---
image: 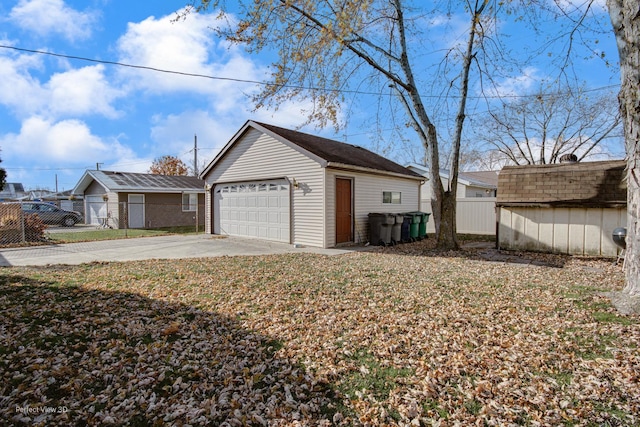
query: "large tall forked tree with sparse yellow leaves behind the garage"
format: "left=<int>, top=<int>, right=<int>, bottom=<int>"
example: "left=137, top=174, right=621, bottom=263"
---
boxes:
left=182, top=0, right=494, bottom=249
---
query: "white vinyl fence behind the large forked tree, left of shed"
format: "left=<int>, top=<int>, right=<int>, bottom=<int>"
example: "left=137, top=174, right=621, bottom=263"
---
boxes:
left=420, top=197, right=496, bottom=236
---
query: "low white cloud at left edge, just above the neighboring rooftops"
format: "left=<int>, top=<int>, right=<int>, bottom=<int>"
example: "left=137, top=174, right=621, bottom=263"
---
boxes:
left=0, top=117, right=135, bottom=166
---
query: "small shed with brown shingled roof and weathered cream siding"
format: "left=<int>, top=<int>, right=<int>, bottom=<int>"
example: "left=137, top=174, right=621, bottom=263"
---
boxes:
left=497, top=160, right=627, bottom=256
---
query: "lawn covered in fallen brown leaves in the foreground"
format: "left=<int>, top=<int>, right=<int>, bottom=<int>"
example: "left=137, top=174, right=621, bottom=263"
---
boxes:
left=0, top=241, right=640, bottom=426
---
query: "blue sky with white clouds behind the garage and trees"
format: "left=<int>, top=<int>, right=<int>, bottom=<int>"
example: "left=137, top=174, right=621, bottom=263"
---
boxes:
left=0, top=0, right=619, bottom=191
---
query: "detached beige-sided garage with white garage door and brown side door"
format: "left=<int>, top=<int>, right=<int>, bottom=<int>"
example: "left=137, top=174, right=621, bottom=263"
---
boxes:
left=200, top=121, right=424, bottom=248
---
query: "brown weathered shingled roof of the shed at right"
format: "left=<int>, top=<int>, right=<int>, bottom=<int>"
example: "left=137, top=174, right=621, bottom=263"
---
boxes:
left=496, top=160, right=627, bottom=207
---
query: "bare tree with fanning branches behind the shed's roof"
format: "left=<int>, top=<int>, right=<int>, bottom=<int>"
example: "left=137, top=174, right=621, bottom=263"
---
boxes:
left=475, top=89, right=622, bottom=165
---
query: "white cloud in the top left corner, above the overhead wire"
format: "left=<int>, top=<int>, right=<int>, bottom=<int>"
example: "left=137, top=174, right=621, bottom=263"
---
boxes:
left=9, top=0, right=96, bottom=41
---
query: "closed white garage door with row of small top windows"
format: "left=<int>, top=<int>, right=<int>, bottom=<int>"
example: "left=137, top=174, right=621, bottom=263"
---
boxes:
left=213, top=179, right=290, bottom=243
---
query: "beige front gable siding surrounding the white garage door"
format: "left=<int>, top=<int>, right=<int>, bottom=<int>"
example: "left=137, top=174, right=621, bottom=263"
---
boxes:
left=205, top=129, right=324, bottom=247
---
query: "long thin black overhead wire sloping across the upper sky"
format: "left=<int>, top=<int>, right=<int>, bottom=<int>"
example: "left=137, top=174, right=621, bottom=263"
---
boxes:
left=0, top=44, right=620, bottom=99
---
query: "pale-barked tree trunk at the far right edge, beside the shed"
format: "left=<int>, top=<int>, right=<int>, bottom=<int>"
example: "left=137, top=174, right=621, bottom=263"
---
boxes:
left=607, top=0, right=640, bottom=313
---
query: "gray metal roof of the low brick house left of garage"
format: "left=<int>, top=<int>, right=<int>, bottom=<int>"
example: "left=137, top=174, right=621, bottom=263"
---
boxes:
left=73, top=170, right=204, bottom=194
